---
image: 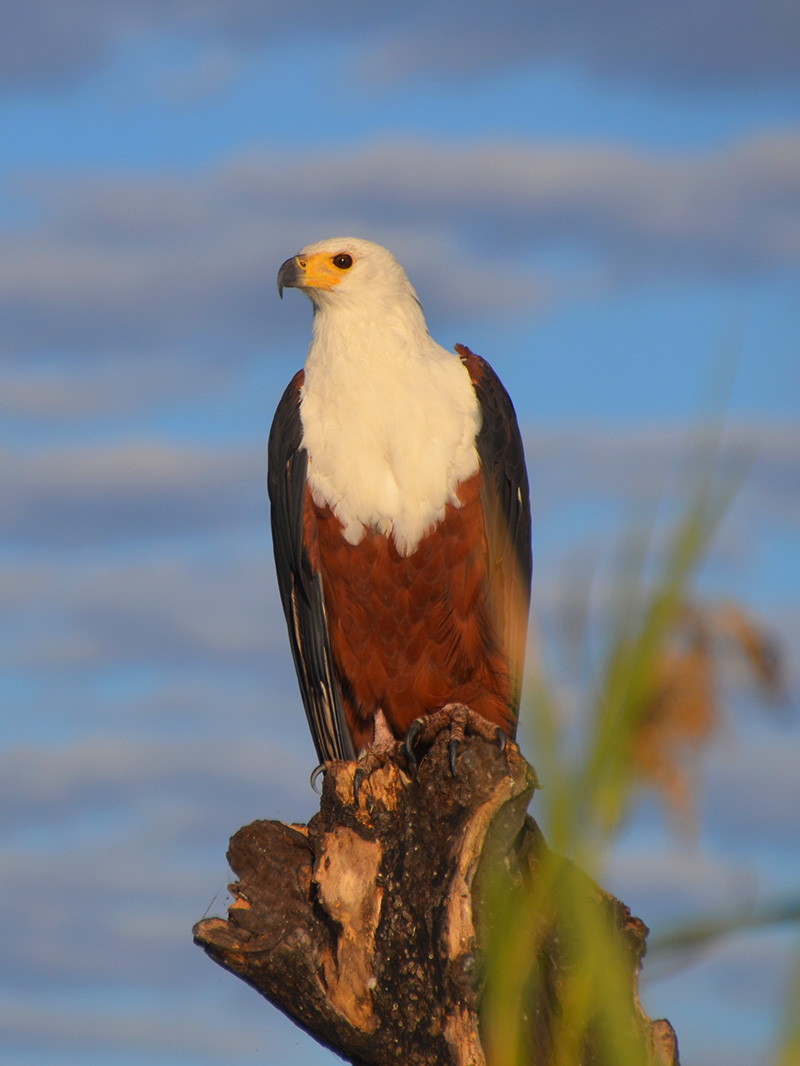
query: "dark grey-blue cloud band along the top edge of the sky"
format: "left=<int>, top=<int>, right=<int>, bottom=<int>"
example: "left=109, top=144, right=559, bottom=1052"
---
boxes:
left=0, top=0, right=800, bottom=90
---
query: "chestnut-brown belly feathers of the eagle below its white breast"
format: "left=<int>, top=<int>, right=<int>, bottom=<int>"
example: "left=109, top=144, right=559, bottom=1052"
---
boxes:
left=303, top=471, right=516, bottom=750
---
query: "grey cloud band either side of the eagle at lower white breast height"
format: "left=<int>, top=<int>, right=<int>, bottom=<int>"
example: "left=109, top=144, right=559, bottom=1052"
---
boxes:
left=0, top=420, right=800, bottom=548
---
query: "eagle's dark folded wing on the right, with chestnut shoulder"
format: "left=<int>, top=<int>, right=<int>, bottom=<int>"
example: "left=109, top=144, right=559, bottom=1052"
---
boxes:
left=455, top=344, right=533, bottom=713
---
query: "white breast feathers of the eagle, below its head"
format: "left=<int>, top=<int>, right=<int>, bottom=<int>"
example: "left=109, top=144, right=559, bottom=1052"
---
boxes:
left=300, top=314, right=481, bottom=555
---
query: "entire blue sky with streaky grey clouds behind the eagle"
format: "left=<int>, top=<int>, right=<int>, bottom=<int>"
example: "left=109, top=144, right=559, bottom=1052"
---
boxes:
left=0, top=8, right=800, bottom=1066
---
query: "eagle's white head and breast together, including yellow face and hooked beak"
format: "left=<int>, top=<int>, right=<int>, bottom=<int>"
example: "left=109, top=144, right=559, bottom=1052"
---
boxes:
left=278, top=238, right=481, bottom=555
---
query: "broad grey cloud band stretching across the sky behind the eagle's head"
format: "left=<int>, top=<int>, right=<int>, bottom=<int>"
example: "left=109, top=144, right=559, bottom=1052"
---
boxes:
left=6, top=130, right=800, bottom=360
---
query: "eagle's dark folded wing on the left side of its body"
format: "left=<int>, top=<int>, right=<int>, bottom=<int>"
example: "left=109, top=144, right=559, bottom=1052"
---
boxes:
left=267, top=370, right=355, bottom=762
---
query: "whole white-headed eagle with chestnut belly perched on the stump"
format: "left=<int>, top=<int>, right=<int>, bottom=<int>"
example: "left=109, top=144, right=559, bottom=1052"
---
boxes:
left=269, top=238, right=531, bottom=765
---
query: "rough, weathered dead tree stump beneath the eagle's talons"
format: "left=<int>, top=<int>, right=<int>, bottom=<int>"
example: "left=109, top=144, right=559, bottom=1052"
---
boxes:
left=194, top=737, right=677, bottom=1066
